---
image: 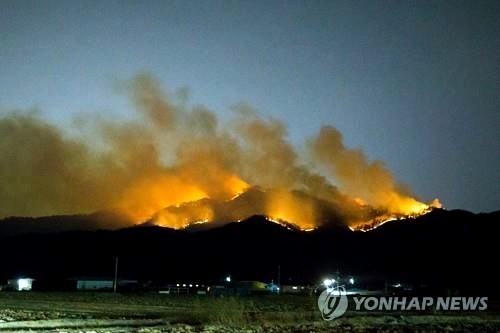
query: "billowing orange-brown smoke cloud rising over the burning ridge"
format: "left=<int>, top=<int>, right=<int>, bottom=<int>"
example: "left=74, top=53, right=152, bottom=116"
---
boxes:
left=0, top=74, right=438, bottom=228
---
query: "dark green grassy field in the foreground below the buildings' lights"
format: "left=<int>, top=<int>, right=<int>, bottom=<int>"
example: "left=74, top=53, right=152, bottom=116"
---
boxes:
left=0, top=292, right=500, bottom=333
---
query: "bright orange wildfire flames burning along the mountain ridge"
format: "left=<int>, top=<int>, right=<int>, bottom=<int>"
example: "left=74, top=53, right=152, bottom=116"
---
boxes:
left=144, top=184, right=441, bottom=231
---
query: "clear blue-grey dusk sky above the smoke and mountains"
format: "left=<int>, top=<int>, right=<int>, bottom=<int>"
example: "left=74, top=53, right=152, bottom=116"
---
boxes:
left=0, top=0, right=500, bottom=212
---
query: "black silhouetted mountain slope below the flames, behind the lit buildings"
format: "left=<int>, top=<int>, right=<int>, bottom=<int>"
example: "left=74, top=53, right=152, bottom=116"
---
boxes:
left=0, top=209, right=500, bottom=292
